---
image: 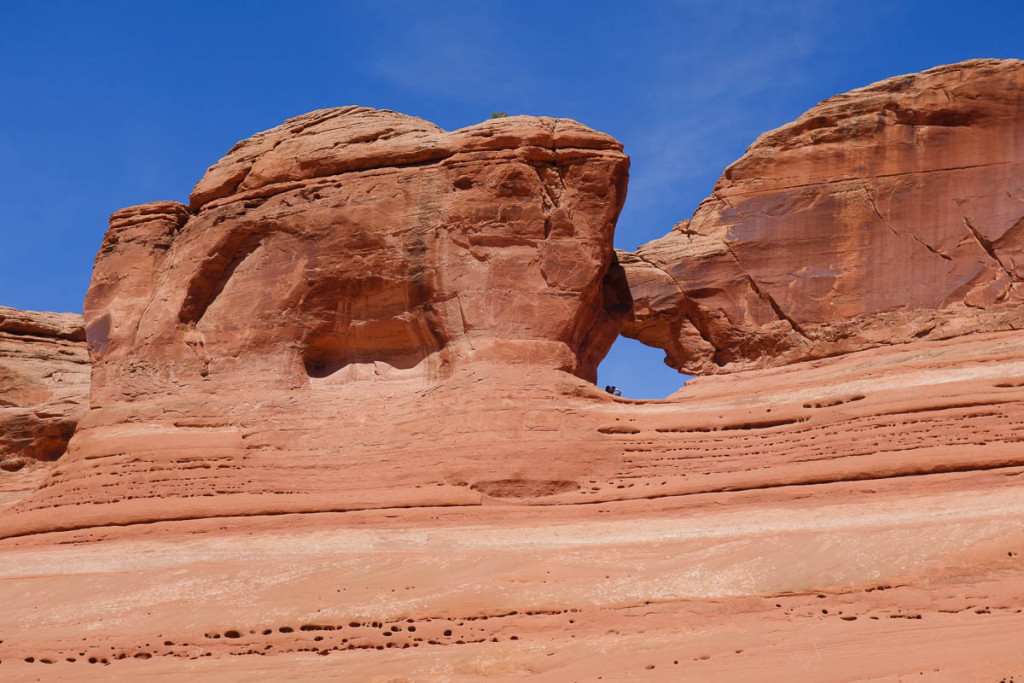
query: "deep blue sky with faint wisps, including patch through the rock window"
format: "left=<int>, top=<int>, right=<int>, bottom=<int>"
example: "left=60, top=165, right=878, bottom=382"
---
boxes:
left=0, top=0, right=1024, bottom=397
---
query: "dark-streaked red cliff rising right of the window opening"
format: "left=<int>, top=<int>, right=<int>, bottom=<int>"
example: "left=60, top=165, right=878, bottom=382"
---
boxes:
left=620, top=59, right=1024, bottom=374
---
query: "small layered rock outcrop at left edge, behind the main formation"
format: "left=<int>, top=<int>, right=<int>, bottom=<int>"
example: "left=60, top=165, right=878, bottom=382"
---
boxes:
left=0, top=306, right=89, bottom=508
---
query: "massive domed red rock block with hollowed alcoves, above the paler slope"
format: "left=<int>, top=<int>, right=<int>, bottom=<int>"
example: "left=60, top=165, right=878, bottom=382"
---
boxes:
left=92, top=108, right=628, bottom=387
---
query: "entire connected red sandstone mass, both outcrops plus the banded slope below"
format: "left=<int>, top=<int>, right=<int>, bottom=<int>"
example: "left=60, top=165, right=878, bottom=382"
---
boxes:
left=0, top=60, right=1024, bottom=683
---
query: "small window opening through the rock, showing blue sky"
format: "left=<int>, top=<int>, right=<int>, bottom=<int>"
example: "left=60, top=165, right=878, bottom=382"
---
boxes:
left=597, top=337, right=692, bottom=398
